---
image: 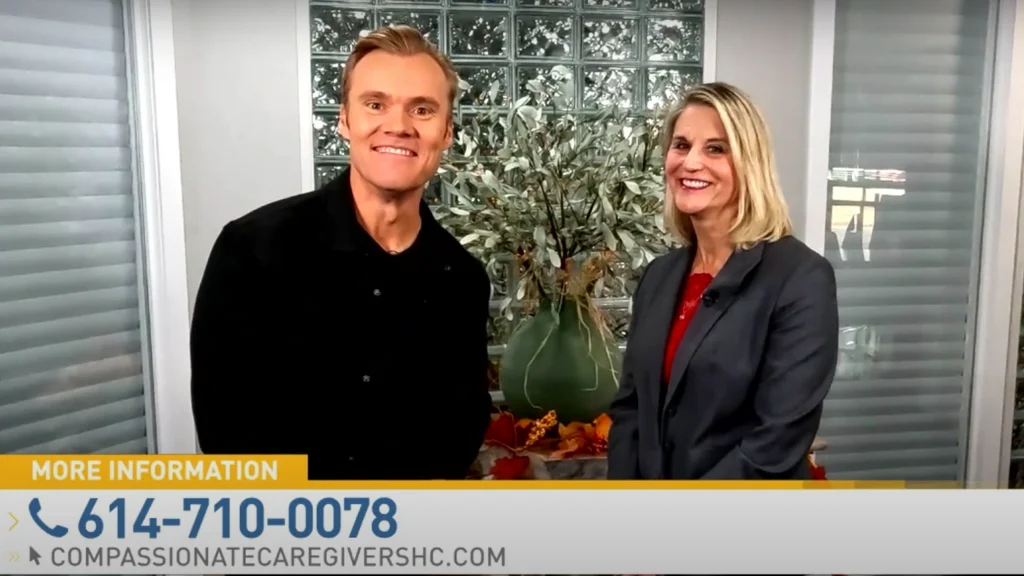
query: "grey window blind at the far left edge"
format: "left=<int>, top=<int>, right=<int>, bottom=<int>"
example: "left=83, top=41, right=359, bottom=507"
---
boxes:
left=0, top=0, right=147, bottom=453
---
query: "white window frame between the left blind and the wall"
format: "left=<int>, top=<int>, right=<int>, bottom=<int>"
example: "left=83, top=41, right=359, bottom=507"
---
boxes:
left=124, top=0, right=197, bottom=454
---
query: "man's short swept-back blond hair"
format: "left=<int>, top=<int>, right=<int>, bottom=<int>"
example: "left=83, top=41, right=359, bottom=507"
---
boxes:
left=341, top=25, right=459, bottom=115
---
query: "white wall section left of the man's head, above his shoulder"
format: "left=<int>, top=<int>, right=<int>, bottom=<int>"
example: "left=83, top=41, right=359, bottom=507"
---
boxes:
left=172, top=0, right=309, bottom=310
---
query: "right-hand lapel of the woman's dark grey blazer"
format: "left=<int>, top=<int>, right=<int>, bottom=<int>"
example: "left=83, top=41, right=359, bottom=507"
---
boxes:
left=662, top=243, right=764, bottom=412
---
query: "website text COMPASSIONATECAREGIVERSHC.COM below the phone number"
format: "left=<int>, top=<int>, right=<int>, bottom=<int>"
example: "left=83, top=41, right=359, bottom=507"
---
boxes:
left=50, top=546, right=505, bottom=568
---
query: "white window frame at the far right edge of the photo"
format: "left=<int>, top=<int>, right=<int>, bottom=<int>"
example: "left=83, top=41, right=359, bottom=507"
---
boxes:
left=967, top=0, right=1024, bottom=488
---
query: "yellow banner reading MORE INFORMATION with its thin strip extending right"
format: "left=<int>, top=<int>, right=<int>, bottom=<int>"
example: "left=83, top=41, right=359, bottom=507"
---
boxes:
left=0, top=454, right=921, bottom=490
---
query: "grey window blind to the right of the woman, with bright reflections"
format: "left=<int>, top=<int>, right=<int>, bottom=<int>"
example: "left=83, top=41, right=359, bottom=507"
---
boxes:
left=820, top=0, right=993, bottom=481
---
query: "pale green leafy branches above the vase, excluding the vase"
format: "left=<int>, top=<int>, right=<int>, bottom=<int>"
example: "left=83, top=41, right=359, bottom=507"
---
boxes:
left=436, top=67, right=669, bottom=318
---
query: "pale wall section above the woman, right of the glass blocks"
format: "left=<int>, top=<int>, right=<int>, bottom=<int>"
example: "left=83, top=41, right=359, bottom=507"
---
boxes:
left=715, top=0, right=813, bottom=238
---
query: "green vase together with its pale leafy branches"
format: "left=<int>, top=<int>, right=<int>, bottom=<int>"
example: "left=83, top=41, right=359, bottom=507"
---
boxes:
left=435, top=67, right=669, bottom=424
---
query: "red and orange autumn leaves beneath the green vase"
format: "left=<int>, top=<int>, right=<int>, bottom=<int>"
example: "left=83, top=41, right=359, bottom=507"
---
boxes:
left=477, top=410, right=611, bottom=480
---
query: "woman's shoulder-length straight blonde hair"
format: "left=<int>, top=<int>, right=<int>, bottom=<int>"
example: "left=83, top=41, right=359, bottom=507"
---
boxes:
left=662, top=82, right=793, bottom=249
